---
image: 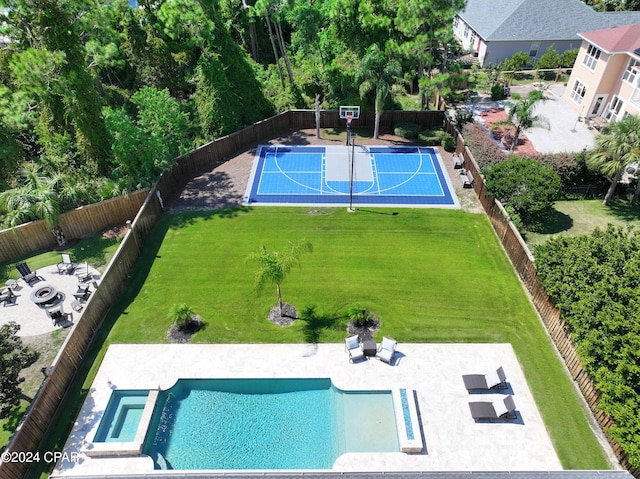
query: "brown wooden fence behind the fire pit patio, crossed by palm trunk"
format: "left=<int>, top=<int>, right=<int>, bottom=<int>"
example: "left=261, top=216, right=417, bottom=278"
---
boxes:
left=0, top=189, right=149, bottom=263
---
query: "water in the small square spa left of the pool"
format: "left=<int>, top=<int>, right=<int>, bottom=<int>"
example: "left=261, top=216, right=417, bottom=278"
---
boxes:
left=93, top=390, right=149, bottom=442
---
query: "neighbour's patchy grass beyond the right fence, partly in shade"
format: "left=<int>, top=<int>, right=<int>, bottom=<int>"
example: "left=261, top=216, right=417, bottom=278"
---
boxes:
left=527, top=200, right=640, bottom=245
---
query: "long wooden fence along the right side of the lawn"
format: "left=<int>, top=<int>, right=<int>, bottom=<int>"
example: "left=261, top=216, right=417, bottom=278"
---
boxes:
left=445, top=119, right=640, bottom=478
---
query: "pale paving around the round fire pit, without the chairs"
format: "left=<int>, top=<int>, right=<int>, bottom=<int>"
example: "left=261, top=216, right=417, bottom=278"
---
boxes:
left=0, top=264, right=99, bottom=337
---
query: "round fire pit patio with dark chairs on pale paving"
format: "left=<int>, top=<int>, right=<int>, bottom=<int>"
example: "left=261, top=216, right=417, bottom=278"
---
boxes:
left=0, top=253, right=99, bottom=336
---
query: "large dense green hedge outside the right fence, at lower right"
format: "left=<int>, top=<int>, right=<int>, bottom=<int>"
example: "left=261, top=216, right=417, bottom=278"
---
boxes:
left=534, top=225, right=640, bottom=467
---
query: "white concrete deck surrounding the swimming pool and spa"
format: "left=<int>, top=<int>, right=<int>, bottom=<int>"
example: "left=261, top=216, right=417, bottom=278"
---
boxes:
left=52, top=343, right=562, bottom=477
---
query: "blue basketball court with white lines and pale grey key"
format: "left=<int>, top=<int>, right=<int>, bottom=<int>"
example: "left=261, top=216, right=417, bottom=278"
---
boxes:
left=244, top=145, right=460, bottom=208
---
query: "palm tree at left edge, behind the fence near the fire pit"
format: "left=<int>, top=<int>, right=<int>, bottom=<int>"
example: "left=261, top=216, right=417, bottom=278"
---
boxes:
left=0, top=166, right=74, bottom=246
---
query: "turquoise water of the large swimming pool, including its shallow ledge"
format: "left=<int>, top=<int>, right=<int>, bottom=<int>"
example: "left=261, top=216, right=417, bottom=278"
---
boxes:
left=143, top=379, right=399, bottom=470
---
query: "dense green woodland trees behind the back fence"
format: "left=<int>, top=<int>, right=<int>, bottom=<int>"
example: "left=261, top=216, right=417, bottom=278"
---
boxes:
left=0, top=0, right=464, bottom=228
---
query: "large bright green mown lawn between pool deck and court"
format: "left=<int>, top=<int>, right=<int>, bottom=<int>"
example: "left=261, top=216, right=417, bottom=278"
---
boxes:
left=28, top=208, right=608, bottom=476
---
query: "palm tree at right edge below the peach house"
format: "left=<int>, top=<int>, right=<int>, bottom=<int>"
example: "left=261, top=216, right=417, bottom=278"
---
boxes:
left=587, top=115, right=640, bottom=205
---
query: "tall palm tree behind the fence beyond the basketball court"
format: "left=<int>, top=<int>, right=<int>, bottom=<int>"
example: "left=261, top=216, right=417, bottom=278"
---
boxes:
left=356, top=43, right=402, bottom=139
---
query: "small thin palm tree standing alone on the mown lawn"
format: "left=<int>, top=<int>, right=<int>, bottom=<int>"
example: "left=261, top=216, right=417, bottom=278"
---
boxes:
left=247, top=238, right=312, bottom=312
